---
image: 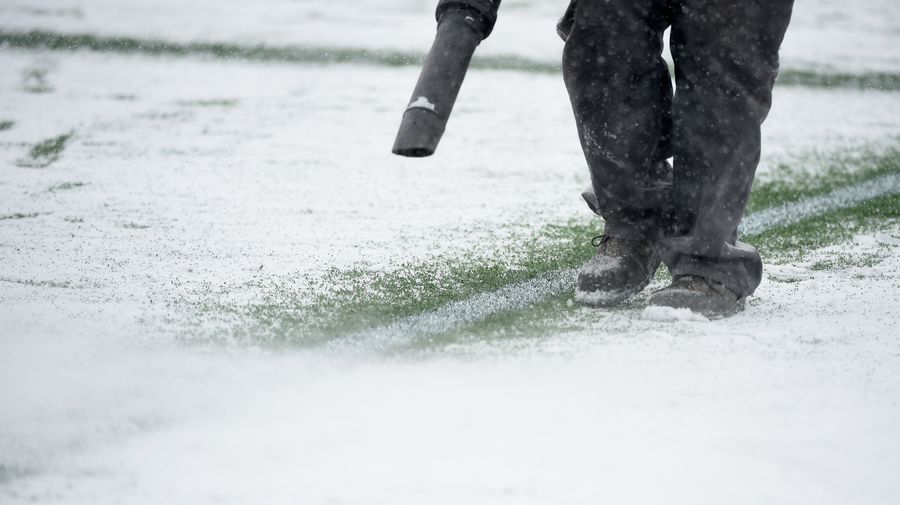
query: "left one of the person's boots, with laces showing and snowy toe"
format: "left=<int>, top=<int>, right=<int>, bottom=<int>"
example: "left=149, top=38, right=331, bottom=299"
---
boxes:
left=575, top=235, right=662, bottom=307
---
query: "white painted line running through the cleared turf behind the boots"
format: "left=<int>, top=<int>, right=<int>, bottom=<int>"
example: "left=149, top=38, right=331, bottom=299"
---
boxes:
left=330, top=170, right=900, bottom=351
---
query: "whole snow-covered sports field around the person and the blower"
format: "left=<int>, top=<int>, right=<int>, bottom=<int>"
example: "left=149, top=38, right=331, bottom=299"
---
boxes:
left=0, top=0, right=900, bottom=504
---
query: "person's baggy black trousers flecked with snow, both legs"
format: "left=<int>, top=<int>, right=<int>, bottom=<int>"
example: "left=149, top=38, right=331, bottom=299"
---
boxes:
left=559, top=0, right=793, bottom=295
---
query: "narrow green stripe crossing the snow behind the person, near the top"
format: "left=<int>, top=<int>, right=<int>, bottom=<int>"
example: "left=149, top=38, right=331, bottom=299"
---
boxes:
left=0, top=30, right=900, bottom=91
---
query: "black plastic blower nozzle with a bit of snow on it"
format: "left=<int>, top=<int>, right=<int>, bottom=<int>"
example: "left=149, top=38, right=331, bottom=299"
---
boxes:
left=393, top=0, right=500, bottom=157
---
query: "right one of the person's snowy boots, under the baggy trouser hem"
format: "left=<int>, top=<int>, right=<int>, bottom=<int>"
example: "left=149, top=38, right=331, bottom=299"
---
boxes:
left=649, top=275, right=745, bottom=318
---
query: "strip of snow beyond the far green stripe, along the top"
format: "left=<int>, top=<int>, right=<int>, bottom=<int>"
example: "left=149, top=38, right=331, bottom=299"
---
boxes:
left=0, top=0, right=900, bottom=73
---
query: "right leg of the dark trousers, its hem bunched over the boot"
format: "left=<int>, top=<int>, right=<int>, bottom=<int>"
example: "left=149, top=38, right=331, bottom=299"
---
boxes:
left=662, top=0, right=793, bottom=296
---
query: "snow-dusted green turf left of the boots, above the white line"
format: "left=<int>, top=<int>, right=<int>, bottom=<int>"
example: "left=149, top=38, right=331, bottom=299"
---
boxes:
left=203, top=221, right=600, bottom=345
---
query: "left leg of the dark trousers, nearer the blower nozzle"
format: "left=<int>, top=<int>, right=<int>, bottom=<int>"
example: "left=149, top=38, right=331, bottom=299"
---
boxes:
left=563, top=0, right=672, bottom=239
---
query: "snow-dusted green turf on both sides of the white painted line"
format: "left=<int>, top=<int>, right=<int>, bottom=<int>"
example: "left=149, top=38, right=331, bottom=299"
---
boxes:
left=183, top=142, right=900, bottom=346
